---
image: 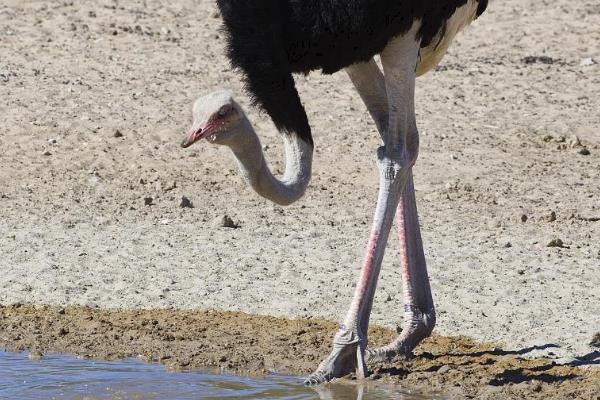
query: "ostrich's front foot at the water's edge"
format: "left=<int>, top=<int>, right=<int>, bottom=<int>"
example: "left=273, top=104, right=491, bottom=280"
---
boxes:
left=304, top=328, right=368, bottom=386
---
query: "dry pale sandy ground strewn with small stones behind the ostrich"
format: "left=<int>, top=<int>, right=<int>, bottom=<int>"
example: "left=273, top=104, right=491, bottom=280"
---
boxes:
left=0, top=0, right=600, bottom=390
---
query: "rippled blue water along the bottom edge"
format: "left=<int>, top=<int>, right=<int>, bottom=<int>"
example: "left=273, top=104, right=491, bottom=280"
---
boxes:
left=0, top=351, right=431, bottom=400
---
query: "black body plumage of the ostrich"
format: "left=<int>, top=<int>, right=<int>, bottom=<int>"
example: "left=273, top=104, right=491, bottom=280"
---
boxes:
left=217, top=0, right=487, bottom=144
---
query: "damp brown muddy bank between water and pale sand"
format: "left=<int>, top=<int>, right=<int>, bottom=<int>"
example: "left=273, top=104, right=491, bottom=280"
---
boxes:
left=0, top=305, right=600, bottom=399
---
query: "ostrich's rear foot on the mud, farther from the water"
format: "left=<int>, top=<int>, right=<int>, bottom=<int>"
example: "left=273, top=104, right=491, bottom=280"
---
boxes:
left=367, top=307, right=435, bottom=363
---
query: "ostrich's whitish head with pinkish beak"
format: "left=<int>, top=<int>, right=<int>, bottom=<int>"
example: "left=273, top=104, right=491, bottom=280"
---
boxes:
left=181, top=90, right=245, bottom=147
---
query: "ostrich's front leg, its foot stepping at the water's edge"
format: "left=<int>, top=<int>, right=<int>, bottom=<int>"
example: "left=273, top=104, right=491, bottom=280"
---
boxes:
left=305, top=30, right=419, bottom=385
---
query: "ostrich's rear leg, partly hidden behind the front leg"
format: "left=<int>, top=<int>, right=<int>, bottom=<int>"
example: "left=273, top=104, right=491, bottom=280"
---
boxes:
left=347, top=60, right=435, bottom=361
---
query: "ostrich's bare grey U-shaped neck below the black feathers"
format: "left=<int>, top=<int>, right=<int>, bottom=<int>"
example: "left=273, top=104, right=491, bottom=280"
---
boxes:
left=230, top=120, right=313, bottom=206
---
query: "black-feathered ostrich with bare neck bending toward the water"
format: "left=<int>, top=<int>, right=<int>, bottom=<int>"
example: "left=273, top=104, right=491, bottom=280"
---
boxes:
left=181, top=0, right=487, bottom=385
